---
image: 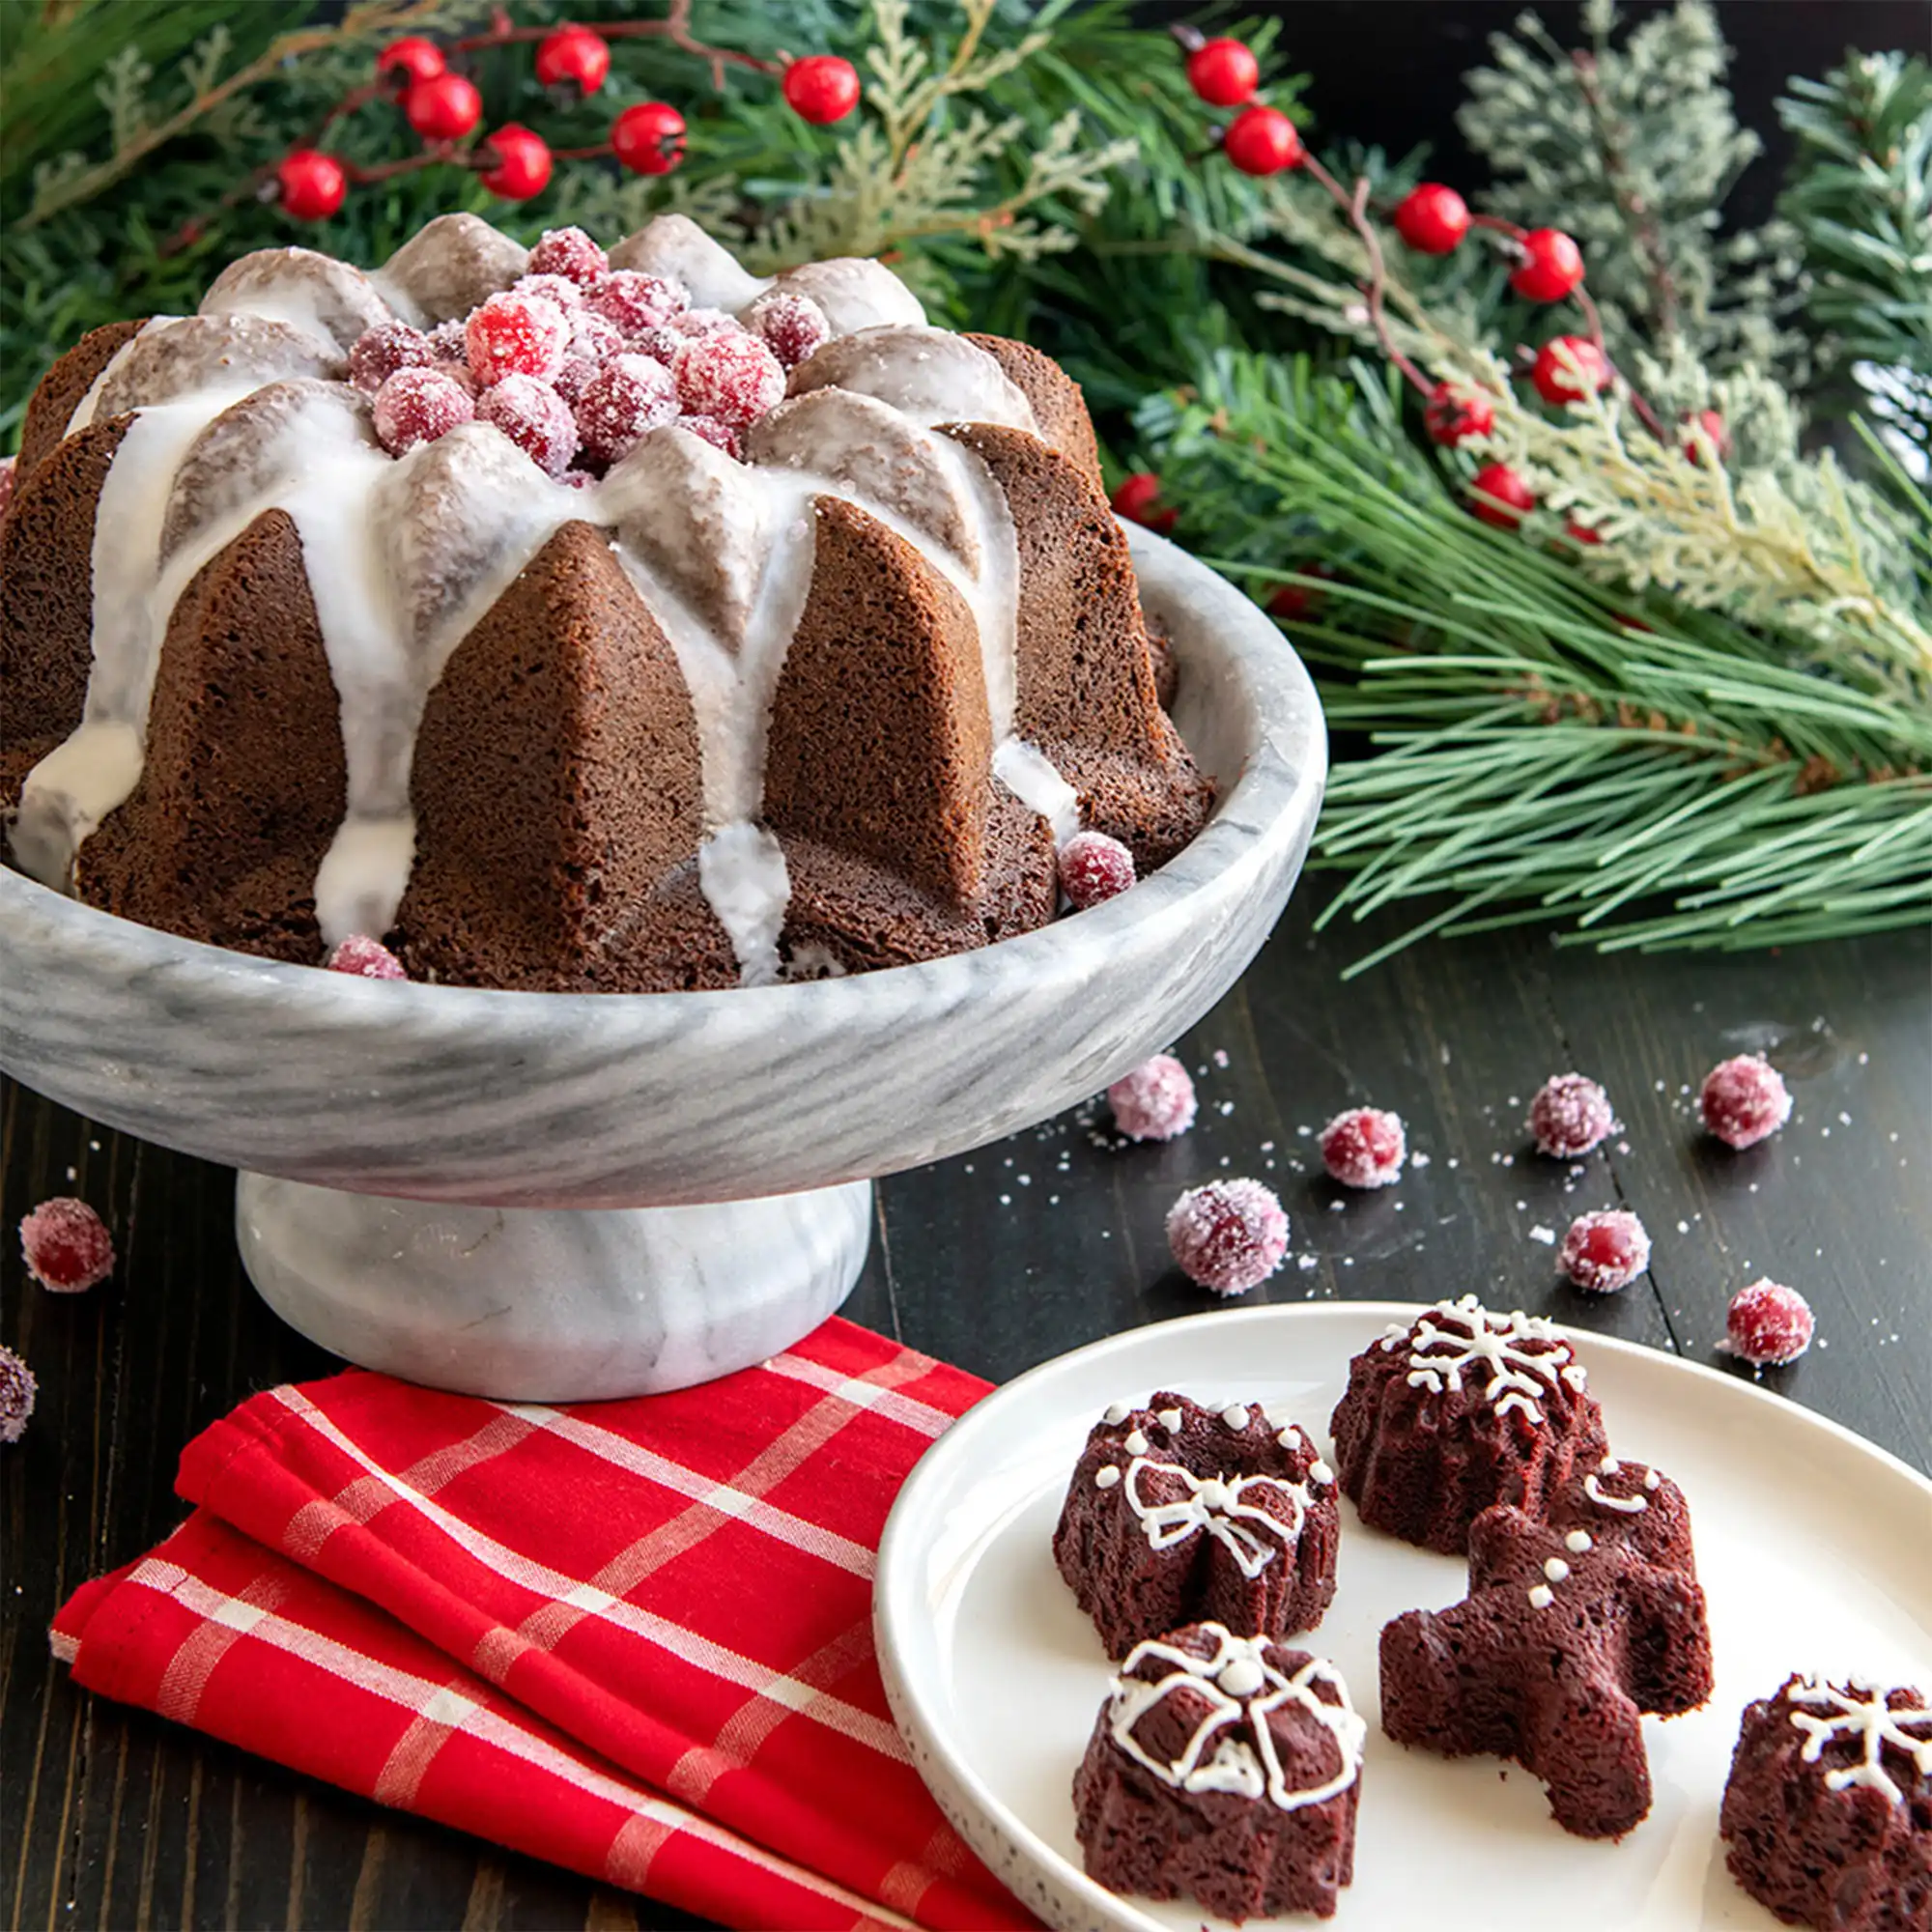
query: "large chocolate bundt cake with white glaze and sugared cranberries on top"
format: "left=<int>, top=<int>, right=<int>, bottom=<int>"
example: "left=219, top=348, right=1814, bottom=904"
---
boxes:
left=0, top=214, right=1213, bottom=993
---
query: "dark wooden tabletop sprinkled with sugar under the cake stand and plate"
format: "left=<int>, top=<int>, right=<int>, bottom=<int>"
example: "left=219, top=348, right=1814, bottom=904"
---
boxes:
left=0, top=912, right=1932, bottom=1928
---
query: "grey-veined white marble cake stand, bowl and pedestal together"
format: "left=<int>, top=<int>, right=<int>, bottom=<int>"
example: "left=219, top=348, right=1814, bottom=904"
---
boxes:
left=0, top=529, right=1327, bottom=1401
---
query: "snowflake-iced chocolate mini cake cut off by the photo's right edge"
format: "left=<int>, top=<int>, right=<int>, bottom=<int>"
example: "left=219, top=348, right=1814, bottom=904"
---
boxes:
left=1719, top=1675, right=1932, bottom=1932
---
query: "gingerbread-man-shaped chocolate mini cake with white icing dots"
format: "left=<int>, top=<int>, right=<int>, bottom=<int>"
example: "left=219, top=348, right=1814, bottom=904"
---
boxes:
left=1381, top=1457, right=1712, bottom=1837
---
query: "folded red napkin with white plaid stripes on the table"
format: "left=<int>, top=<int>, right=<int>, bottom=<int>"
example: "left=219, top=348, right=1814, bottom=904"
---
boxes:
left=54, top=1320, right=1034, bottom=1928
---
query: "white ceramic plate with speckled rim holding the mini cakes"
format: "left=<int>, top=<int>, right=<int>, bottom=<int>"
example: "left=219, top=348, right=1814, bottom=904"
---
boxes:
left=875, top=1302, right=1932, bottom=1932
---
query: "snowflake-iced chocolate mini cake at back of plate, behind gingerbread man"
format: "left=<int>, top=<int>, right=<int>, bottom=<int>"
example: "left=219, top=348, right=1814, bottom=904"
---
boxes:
left=1329, top=1294, right=1605, bottom=1553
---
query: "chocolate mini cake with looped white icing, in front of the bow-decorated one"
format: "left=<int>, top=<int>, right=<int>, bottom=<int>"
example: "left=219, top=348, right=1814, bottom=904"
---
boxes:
left=1074, top=1623, right=1368, bottom=1920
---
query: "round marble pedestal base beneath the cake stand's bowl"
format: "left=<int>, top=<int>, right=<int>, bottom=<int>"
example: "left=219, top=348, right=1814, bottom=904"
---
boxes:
left=236, top=1173, right=871, bottom=1403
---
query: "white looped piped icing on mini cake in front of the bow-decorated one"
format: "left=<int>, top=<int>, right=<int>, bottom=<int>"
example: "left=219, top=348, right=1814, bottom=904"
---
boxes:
left=1111, top=1623, right=1368, bottom=1810
